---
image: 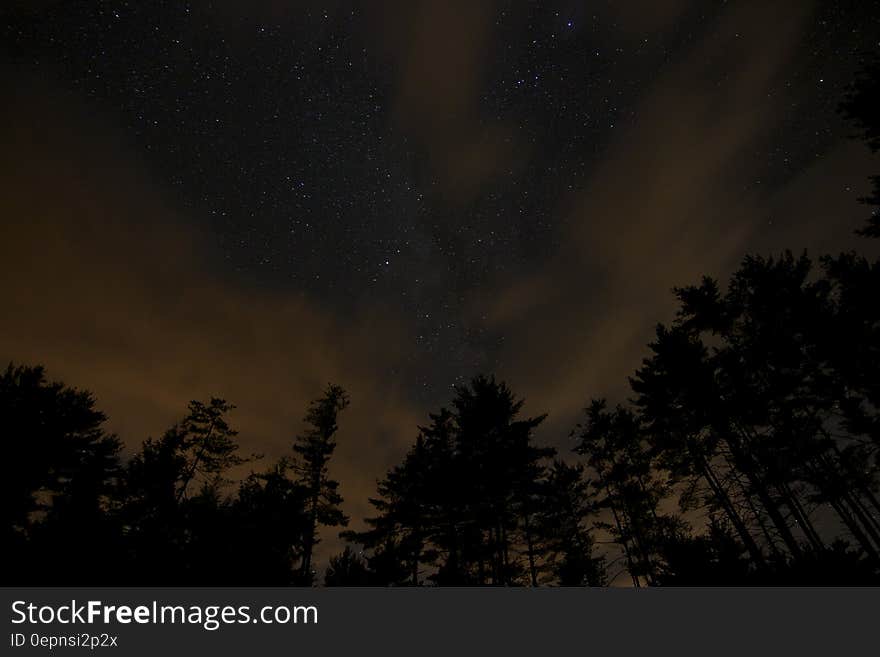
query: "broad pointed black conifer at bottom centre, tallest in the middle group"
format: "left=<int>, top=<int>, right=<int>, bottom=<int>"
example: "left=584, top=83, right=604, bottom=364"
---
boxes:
left=344, top=376, right=568, bottom=586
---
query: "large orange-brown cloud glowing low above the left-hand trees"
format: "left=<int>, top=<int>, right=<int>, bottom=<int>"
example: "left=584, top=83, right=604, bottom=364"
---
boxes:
left=0, top=75, right=422, bottom=560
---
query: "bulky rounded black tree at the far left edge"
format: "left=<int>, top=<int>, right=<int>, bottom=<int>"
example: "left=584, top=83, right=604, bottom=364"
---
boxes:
left=0, top=363, right=121, bottom=584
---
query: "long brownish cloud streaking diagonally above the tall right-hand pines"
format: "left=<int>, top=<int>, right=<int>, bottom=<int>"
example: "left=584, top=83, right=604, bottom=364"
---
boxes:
left=472, top=3, right=852, bottom=436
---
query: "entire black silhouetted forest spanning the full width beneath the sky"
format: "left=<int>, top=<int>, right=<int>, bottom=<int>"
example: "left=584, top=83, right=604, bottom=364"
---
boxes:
left=0, top=60, right=880, bottom=587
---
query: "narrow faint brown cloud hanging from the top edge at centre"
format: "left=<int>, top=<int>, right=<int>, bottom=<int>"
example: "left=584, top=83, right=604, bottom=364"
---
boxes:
left=367, top=0, right=525, bottom=203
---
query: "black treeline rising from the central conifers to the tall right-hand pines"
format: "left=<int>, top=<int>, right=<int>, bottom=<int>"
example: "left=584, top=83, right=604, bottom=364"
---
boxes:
left=331, top=253, right=880, bottom=586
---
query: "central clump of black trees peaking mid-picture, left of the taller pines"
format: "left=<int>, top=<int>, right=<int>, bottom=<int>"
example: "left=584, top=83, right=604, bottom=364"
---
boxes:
left=329, top=376, right=605, bottom=586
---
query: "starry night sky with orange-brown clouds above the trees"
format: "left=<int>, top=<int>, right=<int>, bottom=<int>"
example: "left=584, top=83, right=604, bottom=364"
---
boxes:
left=0, top=0, right=880, bottom=552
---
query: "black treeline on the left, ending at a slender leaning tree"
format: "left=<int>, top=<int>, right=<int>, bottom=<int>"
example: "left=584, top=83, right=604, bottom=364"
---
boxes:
left=0, top=364, right=348, bottom=586
